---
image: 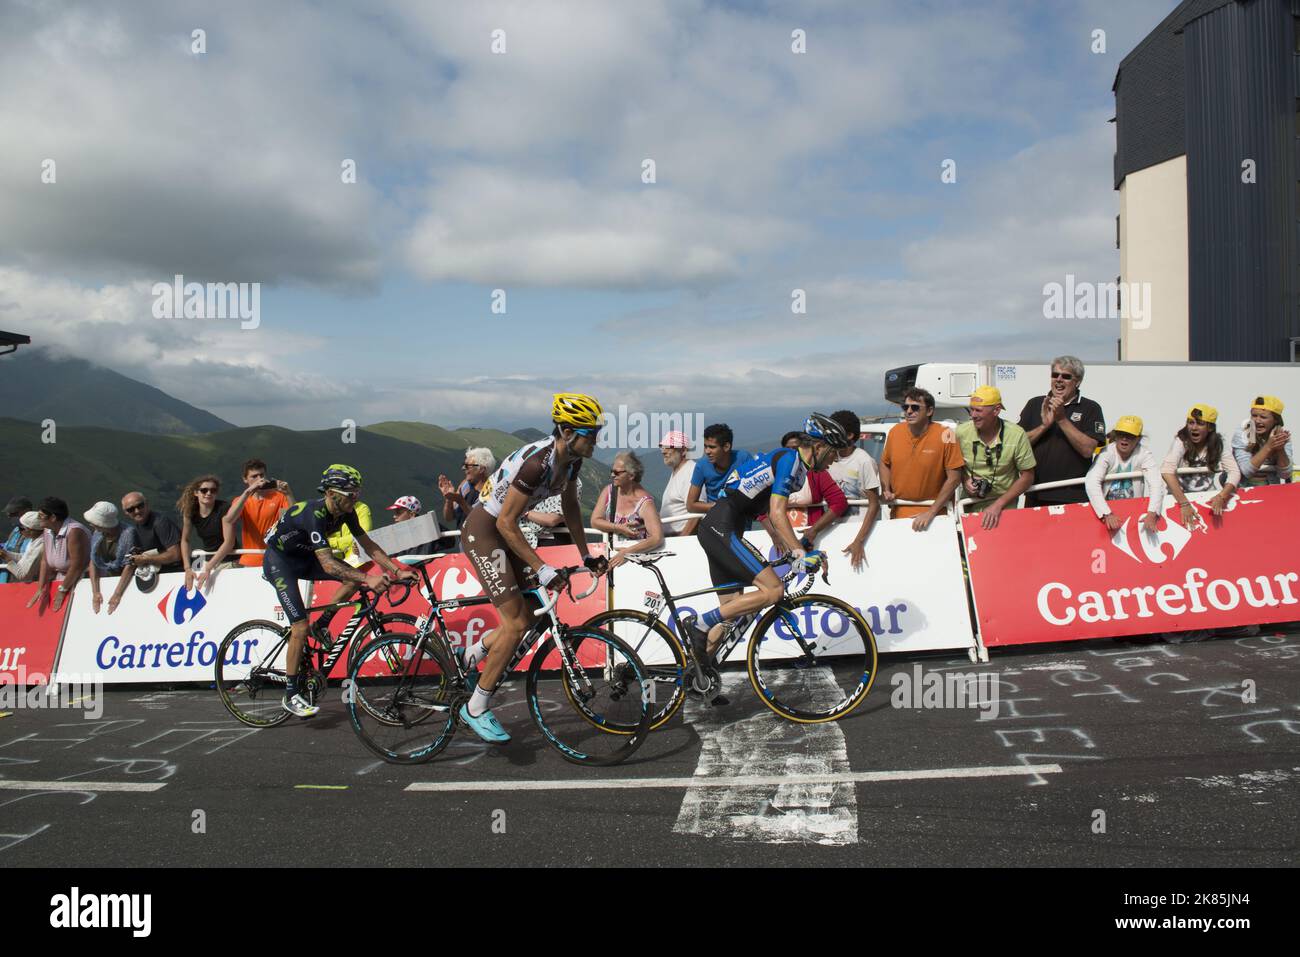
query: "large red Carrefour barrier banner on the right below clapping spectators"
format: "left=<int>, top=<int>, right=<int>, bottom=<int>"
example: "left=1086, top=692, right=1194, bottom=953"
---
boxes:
left=962, top=485, right=1300, bottom=645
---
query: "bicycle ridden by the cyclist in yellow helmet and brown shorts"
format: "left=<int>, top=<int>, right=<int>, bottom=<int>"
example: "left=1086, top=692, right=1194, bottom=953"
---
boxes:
left=345, top=559, right=651, bottom=766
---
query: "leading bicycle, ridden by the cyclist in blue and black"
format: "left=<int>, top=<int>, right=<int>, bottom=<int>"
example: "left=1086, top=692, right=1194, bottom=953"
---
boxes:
left=586, top=551, right=876, bottom=728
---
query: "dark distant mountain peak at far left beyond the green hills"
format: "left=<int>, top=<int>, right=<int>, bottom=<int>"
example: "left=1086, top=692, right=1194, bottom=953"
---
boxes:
left=0, top=348, right=235, bottom=436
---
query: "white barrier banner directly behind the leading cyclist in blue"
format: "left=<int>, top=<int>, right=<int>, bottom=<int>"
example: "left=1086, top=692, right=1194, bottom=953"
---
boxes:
left=610, top=515, right=975, bottom=664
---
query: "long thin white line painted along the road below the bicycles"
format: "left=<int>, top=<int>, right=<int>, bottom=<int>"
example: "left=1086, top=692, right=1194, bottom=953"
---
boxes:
left=406, top=764, right=1062, bottom=792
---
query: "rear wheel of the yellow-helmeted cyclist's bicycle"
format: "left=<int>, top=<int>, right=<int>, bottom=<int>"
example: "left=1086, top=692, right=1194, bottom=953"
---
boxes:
left=343, top=633, right=464, bottom=765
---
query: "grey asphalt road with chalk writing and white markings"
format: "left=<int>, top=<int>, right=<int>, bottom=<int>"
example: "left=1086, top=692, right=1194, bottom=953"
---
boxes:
left=0, top=633, right=1300, bottom=867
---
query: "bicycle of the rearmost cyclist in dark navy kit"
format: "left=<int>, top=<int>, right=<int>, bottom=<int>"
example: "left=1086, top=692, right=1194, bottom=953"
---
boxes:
left=216, top=581, right=416, bottom=728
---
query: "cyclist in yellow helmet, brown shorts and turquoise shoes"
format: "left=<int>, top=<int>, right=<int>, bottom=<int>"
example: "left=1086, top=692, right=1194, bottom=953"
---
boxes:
left=460, top=393, right=606, bottom=742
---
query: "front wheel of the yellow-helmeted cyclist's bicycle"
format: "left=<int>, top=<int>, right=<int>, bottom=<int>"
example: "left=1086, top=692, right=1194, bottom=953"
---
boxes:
left=528, top=625, right=654, bottom=766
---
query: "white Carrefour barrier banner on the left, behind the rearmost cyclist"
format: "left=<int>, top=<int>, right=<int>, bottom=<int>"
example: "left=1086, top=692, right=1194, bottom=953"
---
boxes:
left=56, top=567, right=299, bottom=683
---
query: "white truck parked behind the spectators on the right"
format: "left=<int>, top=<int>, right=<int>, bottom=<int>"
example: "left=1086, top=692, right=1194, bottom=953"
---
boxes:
left=863, top=359, right=1300, bottom=458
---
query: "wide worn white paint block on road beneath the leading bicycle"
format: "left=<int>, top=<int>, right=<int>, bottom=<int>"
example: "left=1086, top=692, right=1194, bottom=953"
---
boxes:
left=672, top=668, right=858, bottom=844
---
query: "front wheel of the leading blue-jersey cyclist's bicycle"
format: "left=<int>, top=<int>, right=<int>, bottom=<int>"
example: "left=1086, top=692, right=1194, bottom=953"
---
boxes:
left=746, top=594, right=876, bottom=724
